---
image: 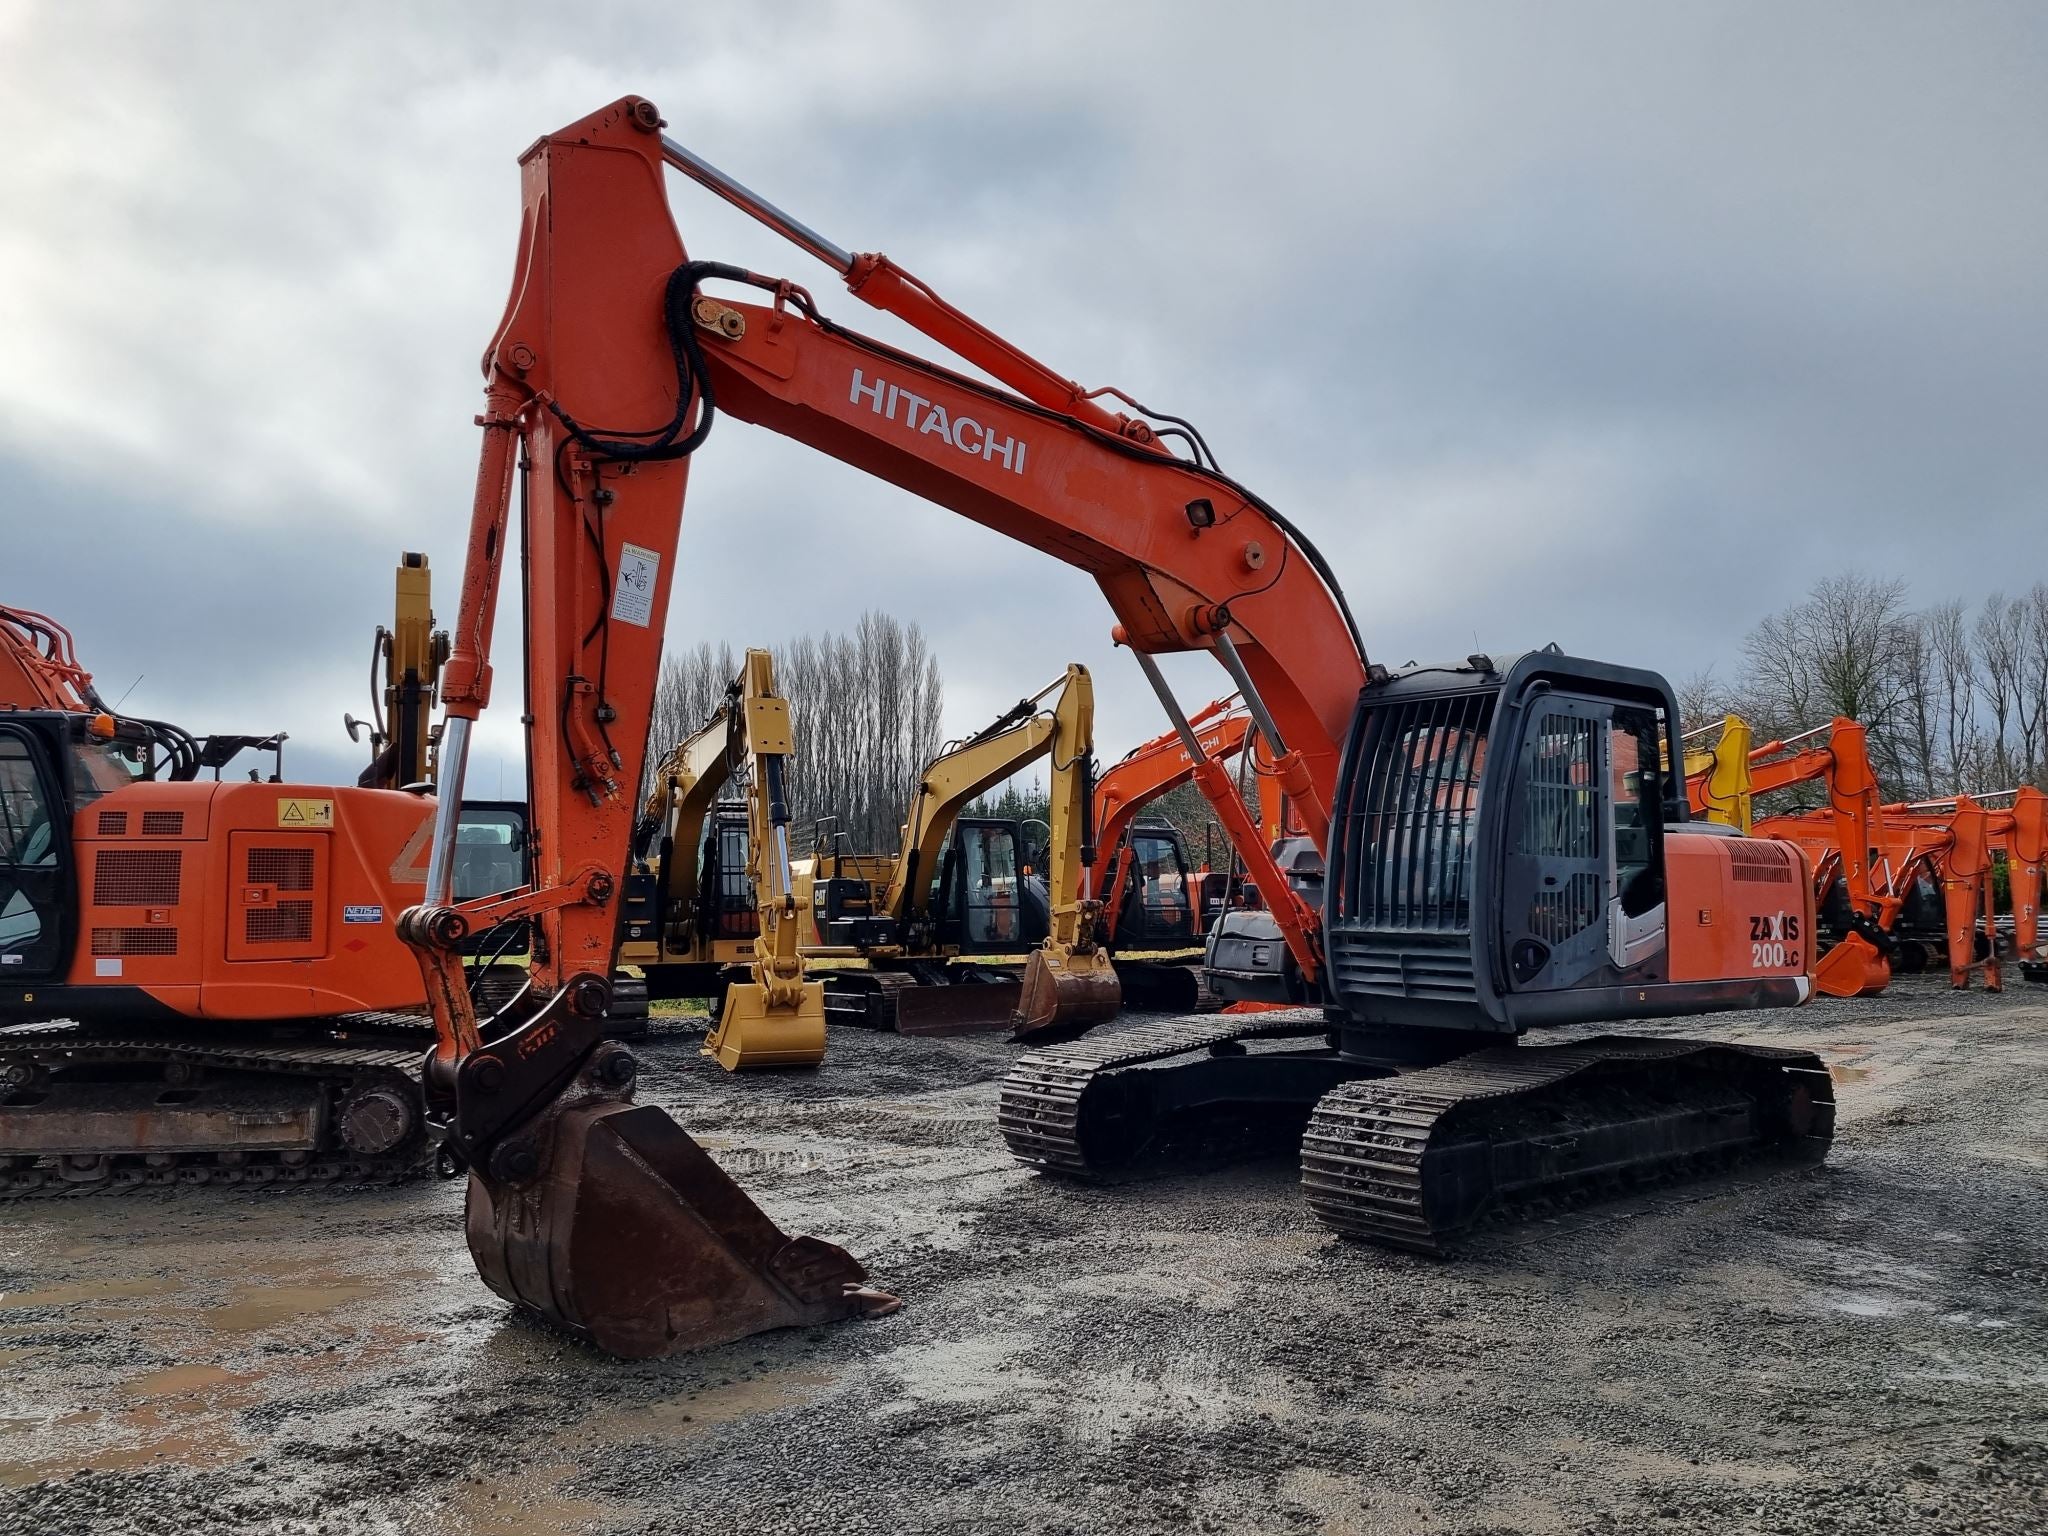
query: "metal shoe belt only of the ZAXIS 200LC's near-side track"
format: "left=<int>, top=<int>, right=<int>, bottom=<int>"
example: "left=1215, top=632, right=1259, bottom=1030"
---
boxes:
left=1300, top=1038, right=1835, bottom=1253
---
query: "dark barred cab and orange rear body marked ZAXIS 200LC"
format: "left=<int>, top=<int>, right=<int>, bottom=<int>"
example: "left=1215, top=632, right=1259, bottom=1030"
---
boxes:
left=1325, top=651, right=1812, bottom=1051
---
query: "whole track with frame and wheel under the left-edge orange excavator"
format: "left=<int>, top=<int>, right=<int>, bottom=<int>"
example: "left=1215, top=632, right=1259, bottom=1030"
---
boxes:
left=0, top=1014, right=432, bottom=1200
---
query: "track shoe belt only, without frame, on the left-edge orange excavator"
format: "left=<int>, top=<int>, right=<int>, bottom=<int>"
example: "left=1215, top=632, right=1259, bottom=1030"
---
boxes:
left=0, top=1012, right=432, bottom=1200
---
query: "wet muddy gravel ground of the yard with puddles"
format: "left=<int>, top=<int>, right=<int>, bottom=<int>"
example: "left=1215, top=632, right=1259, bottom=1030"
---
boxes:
left=0, top=981, right=2048, bottom=1536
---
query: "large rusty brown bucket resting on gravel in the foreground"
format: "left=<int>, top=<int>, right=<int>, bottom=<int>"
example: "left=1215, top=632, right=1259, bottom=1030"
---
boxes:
left=467, top=1100, right=901, bottom=1360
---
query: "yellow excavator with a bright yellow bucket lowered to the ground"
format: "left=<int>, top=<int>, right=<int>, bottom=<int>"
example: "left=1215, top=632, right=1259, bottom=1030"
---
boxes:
left=618, top=649, right=825, bottom=1071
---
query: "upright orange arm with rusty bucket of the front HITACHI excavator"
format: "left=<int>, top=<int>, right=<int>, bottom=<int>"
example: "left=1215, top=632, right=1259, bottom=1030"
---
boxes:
left=399, top=100, right=895, bottom=1356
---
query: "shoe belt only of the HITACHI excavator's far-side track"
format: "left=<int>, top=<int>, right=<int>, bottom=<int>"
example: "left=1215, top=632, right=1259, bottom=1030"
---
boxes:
left=995, top=1008, right=1329, bottom=1180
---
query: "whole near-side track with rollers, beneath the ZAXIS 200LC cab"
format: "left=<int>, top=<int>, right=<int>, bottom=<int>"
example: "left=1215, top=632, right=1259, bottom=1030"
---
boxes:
left=1300, top=1034, right=1835, bottom=1253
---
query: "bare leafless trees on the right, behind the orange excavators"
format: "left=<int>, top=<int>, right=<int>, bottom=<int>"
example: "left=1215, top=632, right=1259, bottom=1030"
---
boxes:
left=1679, top=571, right=2048, bottom=799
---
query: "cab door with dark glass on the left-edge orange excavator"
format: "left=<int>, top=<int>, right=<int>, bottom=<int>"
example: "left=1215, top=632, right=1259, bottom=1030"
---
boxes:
left=0, top=725, right=72, bottom=987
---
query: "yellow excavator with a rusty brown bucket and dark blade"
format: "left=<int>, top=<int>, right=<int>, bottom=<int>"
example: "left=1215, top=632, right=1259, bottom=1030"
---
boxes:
left=797, top=666, right=1120, bottom=1038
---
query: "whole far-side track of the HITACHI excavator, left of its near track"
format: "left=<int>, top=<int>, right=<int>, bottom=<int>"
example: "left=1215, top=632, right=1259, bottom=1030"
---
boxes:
left=995, top=1008, right=1354, bottom=1180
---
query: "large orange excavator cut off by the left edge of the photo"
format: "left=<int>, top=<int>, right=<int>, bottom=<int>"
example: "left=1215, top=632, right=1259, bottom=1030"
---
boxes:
left=0, top=608, right=452, bottom=1198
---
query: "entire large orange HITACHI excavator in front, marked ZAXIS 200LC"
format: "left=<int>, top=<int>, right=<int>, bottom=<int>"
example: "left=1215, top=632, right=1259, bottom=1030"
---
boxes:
left=376, top=96, right=1833, bottom=1354
